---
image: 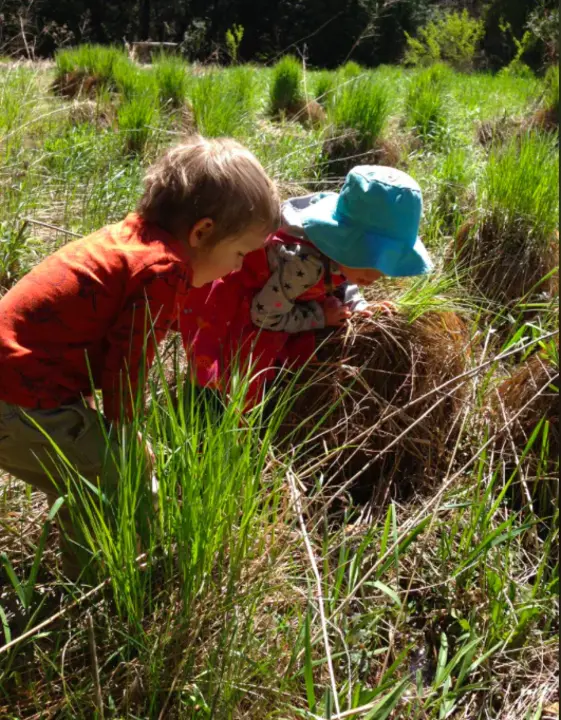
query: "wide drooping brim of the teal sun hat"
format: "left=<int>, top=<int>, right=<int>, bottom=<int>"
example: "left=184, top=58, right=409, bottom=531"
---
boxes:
left=298, top=195, right=433, bottom=277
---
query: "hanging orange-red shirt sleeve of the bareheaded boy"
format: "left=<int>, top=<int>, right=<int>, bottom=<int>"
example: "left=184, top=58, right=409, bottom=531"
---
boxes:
left=101, top=266, right=180, bottom=422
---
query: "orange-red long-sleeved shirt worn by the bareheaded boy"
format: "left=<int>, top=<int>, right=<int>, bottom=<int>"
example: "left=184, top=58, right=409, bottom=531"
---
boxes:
left=0, top=214, right=191, bottom=420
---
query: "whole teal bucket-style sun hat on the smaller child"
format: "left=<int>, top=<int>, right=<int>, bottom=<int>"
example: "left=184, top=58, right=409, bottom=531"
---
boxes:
left=298, top=165, right=433, bottom=277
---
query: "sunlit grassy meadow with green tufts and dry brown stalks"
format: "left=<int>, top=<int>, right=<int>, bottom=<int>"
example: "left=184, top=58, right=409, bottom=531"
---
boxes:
left=0, top=46, right=559, bottom=720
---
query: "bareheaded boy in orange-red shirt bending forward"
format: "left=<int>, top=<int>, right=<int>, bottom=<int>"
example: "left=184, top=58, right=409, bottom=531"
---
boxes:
left=0, top=138, right=280, bottom=567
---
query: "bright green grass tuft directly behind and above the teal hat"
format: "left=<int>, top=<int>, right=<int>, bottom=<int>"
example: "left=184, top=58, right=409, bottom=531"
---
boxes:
left=333, top=77, right=390, bottom=149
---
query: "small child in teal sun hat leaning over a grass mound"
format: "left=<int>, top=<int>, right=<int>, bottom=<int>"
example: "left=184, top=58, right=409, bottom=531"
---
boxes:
left=181, top=166, right=432, bottom=405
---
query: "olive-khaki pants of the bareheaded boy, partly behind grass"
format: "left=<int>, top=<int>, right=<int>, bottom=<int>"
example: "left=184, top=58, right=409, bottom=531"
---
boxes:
left=0, top=400, right=150, bottom=579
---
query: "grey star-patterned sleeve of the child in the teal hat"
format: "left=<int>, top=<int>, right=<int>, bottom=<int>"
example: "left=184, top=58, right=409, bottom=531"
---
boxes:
left=251, top=245, right=325, bottom=333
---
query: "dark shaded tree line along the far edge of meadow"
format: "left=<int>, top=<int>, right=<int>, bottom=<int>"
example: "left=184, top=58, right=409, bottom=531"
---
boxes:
left=0, top=0, right=556, bottom=68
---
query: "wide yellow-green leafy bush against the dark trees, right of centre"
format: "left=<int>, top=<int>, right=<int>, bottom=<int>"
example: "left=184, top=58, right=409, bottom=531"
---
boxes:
left=404, top=10, right=485, bottom=71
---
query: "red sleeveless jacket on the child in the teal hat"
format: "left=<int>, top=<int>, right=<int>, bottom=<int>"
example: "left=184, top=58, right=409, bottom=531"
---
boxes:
left=180, top=232, right=346, bottom=406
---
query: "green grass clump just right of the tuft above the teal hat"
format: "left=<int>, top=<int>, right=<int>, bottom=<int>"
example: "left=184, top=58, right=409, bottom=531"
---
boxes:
left=405, top=65, right=447, bottom=142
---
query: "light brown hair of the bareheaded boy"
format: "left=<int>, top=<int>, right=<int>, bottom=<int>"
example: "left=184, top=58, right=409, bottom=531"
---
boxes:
left=137, top=136, right=280, bottom=244
